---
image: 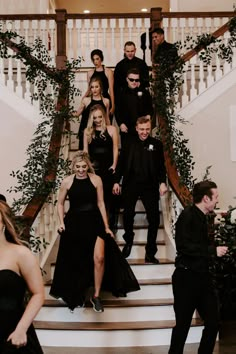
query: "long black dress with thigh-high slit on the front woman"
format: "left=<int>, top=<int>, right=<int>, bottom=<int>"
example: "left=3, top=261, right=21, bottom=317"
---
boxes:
left=50, top=177, right=139, bottom=310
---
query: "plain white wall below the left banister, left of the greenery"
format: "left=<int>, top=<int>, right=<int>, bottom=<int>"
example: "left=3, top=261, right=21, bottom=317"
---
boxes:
left=0, top=86, right=39, bottom=204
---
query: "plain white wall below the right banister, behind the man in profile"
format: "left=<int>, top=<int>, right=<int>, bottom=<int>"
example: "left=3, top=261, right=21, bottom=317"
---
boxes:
left=179, top=84, right=236, bottom=209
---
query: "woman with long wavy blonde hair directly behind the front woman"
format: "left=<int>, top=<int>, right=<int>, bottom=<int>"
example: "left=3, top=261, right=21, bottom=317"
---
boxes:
left=84, top=105, right=119, bottom=230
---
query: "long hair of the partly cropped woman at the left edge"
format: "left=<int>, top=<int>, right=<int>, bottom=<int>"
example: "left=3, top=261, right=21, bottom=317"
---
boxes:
left=0, top=200, right=21, bottom=245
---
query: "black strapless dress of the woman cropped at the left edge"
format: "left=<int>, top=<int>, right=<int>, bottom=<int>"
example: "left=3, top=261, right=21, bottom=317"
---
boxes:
left=0, top=269, right=43, bottom=354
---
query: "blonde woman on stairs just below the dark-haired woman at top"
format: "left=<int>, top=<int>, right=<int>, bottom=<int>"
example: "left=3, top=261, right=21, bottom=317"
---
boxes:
left=75, top=77, right=110, bottom=150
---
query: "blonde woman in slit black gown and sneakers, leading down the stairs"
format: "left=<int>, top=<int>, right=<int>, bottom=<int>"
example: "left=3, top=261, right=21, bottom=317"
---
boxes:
left=50, top=151, right=139, bottom=312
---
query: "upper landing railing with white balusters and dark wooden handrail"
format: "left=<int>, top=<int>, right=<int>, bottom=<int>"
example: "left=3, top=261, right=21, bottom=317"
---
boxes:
left=0, top=8, right=234, bottom=67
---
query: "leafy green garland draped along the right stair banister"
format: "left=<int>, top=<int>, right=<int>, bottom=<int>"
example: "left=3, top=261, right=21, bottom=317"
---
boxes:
left=152, top=17, right=236, bottom=194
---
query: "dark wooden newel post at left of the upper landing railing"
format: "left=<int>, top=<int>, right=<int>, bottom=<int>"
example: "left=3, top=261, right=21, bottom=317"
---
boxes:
left=56, top=9, right=67, bottom=70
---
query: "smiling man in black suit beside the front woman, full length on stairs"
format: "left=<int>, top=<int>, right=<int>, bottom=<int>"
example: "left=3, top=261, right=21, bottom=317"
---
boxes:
left=113, top=117, right=167, bottom=264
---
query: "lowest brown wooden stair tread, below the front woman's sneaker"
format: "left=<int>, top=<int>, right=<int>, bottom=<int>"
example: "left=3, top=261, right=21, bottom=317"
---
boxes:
left=34, top=319, right=203, bottom=331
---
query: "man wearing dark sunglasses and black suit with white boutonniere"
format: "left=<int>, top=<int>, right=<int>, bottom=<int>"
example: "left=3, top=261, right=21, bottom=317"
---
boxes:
left=116, top=68, right=153, bottom=146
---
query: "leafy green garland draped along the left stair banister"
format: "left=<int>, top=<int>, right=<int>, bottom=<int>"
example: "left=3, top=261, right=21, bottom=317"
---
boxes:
left=0, top=28, right=81, bottom=213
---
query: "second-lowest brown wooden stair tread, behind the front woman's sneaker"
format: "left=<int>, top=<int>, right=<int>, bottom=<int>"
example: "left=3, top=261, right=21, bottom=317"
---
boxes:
left=44, top=298, right=173, bottom=308
